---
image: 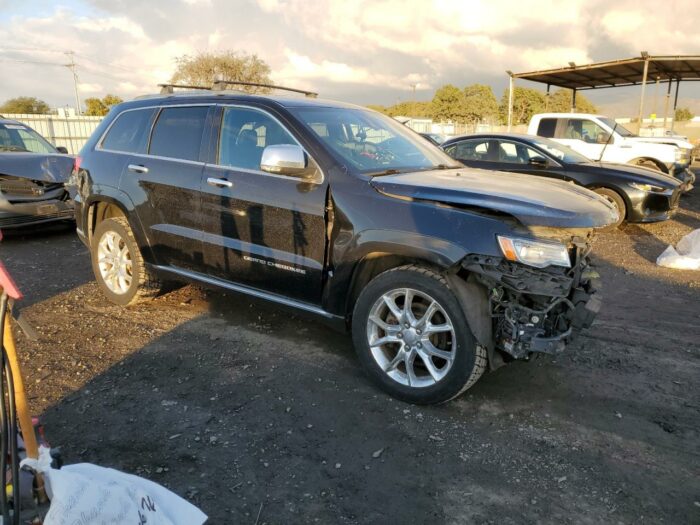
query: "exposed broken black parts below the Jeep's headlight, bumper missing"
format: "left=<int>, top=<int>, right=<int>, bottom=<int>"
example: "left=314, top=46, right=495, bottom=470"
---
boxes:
left=462, top=240, right=601, bottom=359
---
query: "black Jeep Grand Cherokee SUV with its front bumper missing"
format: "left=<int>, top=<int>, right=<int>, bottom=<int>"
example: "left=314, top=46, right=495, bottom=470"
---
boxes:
left=72, top=87, right=617, bottom=403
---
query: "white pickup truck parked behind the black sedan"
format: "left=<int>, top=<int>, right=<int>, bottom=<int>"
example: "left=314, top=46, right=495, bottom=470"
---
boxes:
left=527, top=113, right=694, bottom=178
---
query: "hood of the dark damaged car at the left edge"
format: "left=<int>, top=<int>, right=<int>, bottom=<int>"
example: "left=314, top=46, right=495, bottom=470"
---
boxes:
left=0, top=152, right=73, bottom=183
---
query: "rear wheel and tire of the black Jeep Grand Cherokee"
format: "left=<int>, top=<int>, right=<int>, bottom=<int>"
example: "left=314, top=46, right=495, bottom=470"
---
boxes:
left=90, top=217, right=163, bottom=306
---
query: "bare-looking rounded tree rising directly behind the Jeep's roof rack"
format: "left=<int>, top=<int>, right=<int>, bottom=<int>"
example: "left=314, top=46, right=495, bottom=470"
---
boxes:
left=171, top=51, right=273, bottom=93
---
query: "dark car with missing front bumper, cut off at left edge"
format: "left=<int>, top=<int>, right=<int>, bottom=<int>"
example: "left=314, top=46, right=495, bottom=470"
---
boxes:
left=0, top=119, right=74, bottom=229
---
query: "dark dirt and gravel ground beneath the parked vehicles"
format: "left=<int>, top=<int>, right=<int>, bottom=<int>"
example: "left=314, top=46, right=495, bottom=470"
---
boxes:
left=0, top=174, right=700, bottom=524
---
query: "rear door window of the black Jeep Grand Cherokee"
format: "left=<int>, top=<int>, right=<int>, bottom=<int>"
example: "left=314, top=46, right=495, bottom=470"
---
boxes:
left=148, top=106, right=209, bottom=161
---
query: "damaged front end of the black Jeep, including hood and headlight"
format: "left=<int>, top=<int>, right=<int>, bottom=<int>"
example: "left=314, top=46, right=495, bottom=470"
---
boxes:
left=375, top=168, right=618, bottom=370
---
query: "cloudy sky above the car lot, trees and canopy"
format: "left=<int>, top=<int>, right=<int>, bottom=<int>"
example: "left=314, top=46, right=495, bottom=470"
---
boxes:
left=0, top=0, right=700, bottom=113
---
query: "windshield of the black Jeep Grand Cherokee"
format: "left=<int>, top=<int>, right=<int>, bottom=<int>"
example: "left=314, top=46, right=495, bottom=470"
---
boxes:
left=292, top=107, right=462, bottom=175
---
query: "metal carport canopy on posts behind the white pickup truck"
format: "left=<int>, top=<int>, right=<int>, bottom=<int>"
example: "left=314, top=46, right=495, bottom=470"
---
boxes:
left=507, top=51, right=700, bottom=129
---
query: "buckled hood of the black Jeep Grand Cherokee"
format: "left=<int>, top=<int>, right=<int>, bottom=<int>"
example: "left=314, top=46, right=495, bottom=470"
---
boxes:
left=370, top=168, right=617, bottom=228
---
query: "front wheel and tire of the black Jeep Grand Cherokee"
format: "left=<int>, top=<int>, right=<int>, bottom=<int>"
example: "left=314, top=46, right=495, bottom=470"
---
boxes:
left=352, top=266, right=486, bottom=404
